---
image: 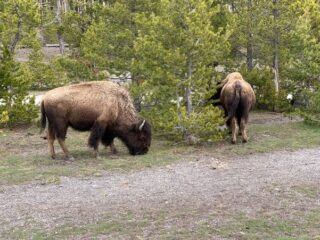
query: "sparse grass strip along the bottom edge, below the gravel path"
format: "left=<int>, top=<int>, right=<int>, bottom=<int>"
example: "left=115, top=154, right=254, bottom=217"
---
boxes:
left=1, top=203, right=320, bottom=240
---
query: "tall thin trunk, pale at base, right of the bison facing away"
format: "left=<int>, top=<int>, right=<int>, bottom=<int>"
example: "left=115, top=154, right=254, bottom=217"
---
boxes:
left=272, top=0, right=280, bottom=93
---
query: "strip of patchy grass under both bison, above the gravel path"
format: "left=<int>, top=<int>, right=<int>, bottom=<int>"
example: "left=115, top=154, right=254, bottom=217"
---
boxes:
left=0, top=118, right=320, bottom=185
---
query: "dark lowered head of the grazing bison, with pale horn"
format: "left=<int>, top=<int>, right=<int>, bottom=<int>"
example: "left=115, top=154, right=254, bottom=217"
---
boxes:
left=120, top=120, right=151, bottom=155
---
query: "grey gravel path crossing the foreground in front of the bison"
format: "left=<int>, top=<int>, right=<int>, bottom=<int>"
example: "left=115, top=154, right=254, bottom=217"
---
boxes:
left=0, top=114, right=320, bottom=239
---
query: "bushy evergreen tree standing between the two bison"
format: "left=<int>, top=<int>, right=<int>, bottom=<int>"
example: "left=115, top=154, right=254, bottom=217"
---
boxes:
left=134, top=0, right=230, bottom=140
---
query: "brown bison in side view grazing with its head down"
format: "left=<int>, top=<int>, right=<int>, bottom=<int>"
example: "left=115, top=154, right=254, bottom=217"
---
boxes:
left=41, top=81, right=151, bottom=158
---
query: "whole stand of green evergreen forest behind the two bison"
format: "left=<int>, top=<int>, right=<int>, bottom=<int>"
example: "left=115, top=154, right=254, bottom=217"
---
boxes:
left=0, top=0, right=320, bottom=141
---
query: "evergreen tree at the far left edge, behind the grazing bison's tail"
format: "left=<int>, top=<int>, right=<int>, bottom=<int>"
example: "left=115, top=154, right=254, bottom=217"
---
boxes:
left=0, top=0, right=40, bottom=124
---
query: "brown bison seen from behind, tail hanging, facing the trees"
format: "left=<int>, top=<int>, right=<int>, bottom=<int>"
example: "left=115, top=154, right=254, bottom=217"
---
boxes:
left=220, top=72, right=256, bottom=143
